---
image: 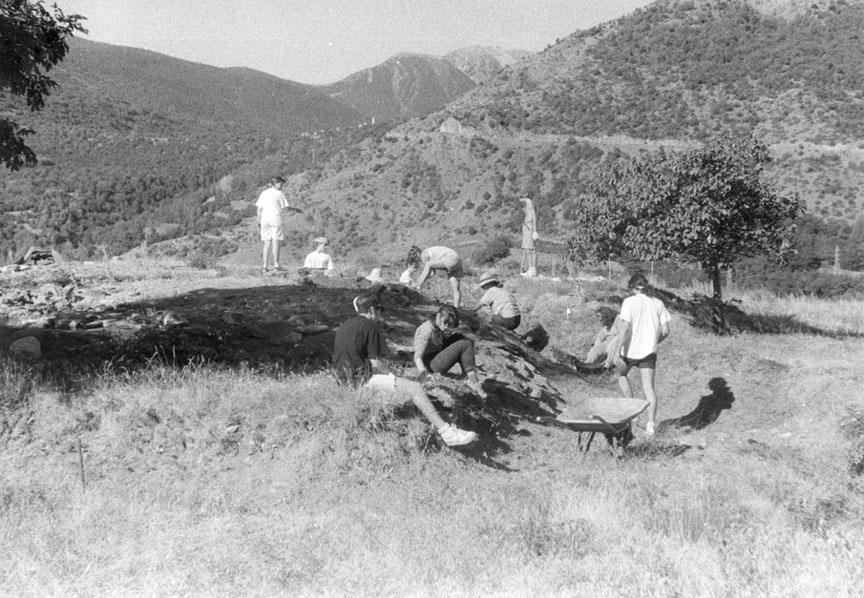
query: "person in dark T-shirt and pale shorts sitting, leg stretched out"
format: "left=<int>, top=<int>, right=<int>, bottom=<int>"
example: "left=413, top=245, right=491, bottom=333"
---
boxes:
left=333, top=295, right=477, bottom=446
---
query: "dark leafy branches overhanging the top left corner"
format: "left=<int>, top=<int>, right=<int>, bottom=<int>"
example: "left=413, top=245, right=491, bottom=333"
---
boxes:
left=0, top=0, right=86, bottom=170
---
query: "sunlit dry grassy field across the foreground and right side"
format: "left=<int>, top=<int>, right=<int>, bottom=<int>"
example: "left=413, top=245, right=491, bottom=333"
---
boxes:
left=0, top=264, right=864, bottom=598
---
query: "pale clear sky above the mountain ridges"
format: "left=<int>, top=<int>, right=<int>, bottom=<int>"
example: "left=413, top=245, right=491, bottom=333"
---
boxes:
left=57, top=0, right=651, bottom=84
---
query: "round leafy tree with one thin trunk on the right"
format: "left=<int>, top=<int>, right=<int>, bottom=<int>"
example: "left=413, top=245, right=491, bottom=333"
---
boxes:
left=569, top=136, right=804, bottom=332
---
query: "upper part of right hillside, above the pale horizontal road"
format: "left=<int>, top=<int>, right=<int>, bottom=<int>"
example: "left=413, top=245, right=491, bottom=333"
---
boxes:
left=448, top=1, right=864, bottom=144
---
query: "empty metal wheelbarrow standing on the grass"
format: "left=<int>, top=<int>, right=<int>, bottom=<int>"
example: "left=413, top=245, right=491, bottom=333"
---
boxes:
left=542, top=398, right=648, bottom=456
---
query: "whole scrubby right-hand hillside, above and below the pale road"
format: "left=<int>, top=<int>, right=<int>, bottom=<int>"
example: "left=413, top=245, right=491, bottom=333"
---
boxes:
left=286, top=1, right=864, bottom=268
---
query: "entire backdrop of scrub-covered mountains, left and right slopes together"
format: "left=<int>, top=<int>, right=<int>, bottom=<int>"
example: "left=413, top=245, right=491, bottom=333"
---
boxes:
left=0, top=0, right=864, bottom=268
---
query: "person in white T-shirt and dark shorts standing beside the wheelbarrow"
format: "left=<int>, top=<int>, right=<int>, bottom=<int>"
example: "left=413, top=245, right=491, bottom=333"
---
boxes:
left=606, top=272, right=672, bottom=436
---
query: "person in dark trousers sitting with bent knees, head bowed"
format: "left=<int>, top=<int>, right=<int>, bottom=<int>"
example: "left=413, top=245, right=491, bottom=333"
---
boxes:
left=414, top=305, right=487, bottom=399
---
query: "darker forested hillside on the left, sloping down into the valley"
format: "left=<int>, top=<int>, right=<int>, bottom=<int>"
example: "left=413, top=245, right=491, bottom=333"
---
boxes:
left=0, top=39, right=364, bottom=257
